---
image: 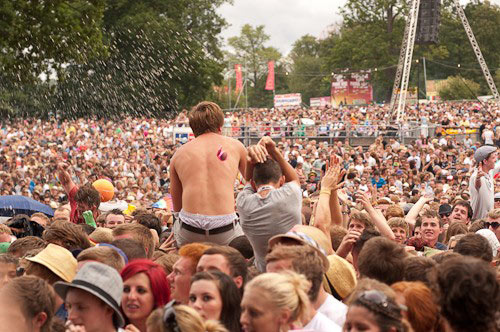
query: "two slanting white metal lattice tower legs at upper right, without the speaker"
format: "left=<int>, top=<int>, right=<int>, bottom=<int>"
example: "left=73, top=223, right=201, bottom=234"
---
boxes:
left=391, top=0, right=500, bottom=122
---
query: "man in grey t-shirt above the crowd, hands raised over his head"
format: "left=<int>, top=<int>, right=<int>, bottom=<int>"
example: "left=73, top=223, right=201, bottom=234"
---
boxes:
left=236, top=136, right=302, bottom=272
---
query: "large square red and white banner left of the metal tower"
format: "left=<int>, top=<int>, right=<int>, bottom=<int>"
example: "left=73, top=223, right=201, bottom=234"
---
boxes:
left=331, top=72, right=373, bottom=106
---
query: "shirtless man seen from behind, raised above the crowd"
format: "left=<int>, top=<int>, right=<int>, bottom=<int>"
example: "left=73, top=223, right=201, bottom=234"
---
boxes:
left=170, top=102, right=247, bottom=247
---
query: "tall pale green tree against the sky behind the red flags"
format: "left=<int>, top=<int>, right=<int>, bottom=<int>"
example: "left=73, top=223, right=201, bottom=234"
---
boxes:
left=227, top=24, right=281, bottom=107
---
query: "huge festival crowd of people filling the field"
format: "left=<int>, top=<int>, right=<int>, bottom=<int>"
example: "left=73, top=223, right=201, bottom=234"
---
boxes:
left=0, top=102, right=500, bottom=332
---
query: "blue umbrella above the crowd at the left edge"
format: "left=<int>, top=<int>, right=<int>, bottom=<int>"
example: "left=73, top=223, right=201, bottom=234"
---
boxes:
left=0, top=195, right=54, bottom=217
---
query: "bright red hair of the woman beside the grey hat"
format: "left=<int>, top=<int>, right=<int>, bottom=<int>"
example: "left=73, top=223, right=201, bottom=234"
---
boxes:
left=120, top=259, right=170, bottom=309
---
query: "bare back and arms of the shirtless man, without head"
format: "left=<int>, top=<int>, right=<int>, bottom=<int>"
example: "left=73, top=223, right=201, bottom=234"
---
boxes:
left=171, top=133, right=246, bottom=216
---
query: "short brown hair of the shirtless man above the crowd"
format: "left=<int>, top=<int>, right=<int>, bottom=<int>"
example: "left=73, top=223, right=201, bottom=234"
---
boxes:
left=188, top=101, right=224, bottom=137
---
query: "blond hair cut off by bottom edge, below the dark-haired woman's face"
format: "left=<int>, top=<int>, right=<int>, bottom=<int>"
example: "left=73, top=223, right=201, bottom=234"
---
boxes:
left=146, top=304, right=228, bottom=332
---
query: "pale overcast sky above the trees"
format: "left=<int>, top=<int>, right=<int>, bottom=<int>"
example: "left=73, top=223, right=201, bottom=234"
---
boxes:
left=219, top=0, right=500, bottom=54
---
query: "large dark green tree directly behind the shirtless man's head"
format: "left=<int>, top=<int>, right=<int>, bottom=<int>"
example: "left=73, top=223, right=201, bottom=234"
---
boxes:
left=52, top=0, right=226, bottom=117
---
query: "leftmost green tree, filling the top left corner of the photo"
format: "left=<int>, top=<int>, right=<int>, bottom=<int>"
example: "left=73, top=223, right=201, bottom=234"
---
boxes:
left=0, top=0, right=106, bottom=83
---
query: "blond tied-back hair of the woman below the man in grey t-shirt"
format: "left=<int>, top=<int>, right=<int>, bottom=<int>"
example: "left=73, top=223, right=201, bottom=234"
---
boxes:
left=243, top=271, right=311, bottom=323
